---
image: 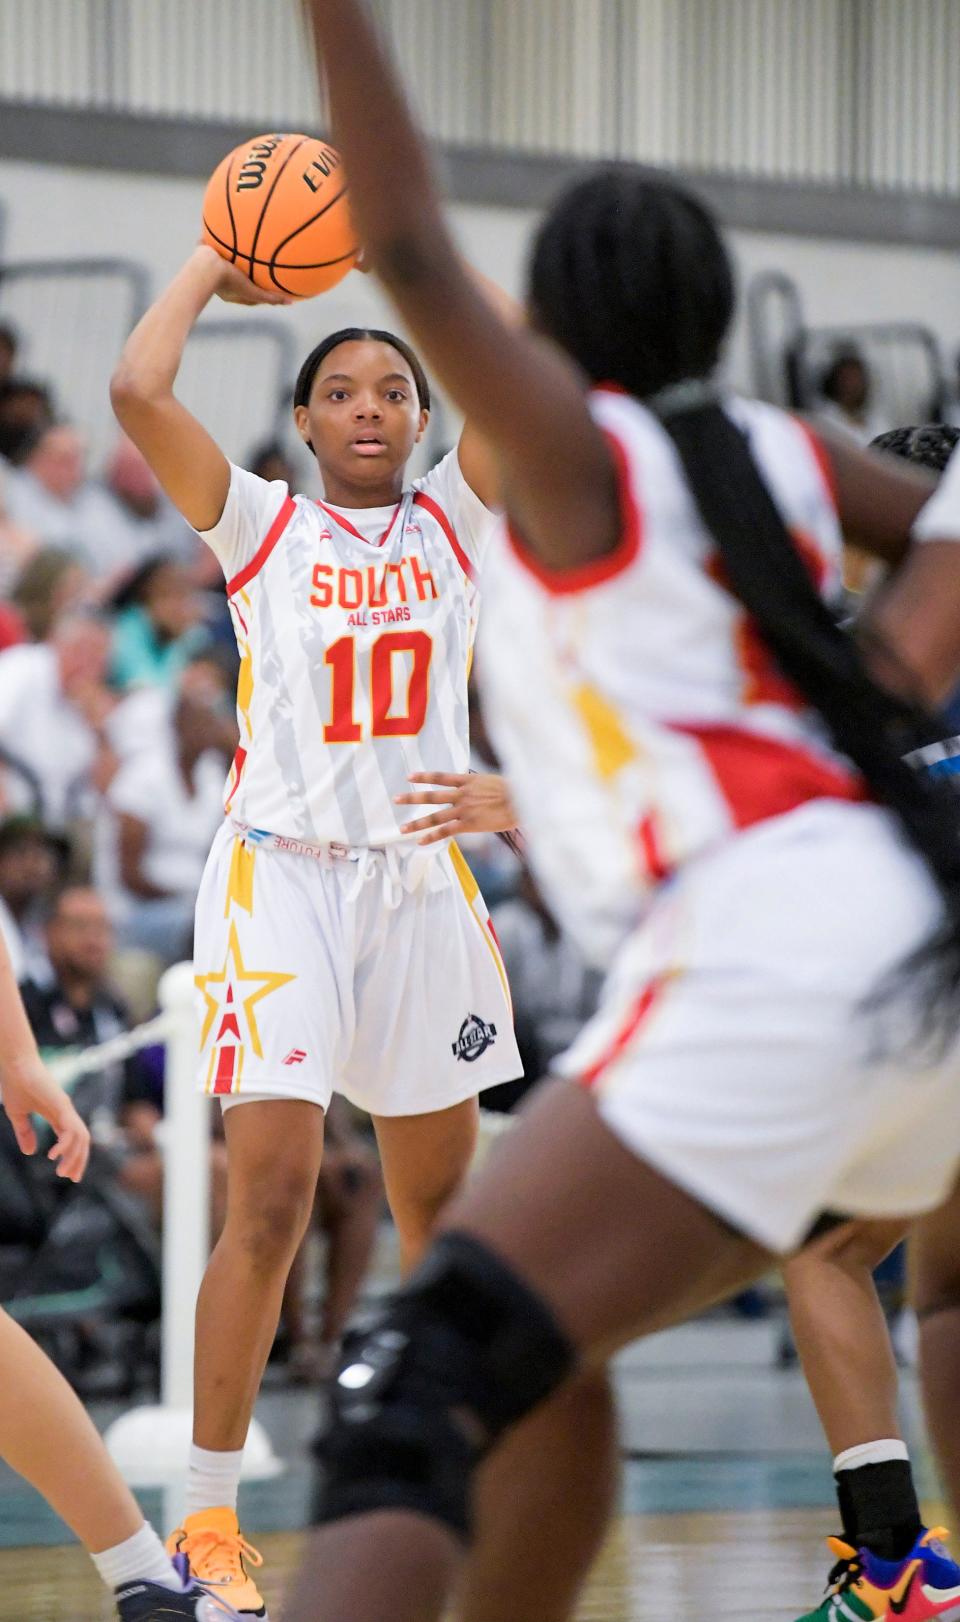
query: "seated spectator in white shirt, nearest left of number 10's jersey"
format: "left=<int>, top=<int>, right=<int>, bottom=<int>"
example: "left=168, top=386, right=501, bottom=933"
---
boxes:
left=94, top=655, right=237, bottom=963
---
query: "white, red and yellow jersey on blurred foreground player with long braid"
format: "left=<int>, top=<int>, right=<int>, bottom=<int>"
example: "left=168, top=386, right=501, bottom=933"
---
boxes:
left=478, top=389, right=863, bottom=963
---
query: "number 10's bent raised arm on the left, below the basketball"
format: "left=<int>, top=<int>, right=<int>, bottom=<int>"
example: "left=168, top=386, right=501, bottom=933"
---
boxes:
left=110, top=247, right=289, bottom=529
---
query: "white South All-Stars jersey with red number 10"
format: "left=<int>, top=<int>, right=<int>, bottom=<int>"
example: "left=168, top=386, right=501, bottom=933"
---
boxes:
left=203, top=451, right=495, bottom=847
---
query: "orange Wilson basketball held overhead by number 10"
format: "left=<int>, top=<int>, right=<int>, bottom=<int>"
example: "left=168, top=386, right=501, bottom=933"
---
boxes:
left=203, top=135, right=360, bottom=298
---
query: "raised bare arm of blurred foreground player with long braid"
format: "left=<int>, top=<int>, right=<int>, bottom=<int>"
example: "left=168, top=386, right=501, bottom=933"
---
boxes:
left=303, top=0, right=619, bottom=566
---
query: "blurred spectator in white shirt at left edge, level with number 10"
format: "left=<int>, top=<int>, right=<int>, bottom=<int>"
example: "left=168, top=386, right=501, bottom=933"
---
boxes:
left=0, top=611, right=117, bottom=829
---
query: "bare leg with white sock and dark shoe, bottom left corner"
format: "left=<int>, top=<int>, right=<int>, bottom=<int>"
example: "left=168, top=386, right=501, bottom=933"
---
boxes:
left=0, top=1312, right=240, bottom=1622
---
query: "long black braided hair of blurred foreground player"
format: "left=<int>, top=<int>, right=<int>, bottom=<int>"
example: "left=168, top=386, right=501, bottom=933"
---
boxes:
left=530, top=167, right=960, bottom=1038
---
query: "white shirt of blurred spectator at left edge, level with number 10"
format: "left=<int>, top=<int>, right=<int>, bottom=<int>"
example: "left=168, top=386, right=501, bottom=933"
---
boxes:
left=0, top=642, right=97, bottom=827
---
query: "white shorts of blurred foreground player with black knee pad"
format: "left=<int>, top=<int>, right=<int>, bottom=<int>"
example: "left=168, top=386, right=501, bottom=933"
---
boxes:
left=555, top=801, right=960, bottom=1252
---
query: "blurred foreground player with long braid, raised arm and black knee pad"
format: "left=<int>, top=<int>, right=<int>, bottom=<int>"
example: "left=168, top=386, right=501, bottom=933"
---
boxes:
left=283, top=0, right=960, bottom=1622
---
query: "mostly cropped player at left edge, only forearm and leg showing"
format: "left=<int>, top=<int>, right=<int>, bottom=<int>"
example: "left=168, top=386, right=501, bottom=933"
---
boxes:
left=0, top=939, right=237, bottom=1622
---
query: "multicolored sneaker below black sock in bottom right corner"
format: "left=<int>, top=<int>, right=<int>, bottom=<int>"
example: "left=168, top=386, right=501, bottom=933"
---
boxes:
left=798, top=1526, right=960, bottom=1622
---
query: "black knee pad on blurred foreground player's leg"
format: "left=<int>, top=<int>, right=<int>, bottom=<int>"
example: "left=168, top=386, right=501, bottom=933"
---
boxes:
left=318, top=1233, right=574, bottom=1536
